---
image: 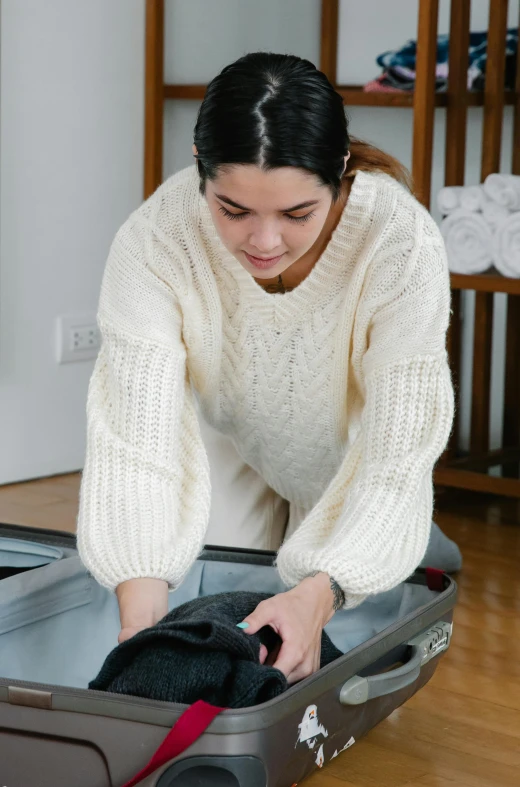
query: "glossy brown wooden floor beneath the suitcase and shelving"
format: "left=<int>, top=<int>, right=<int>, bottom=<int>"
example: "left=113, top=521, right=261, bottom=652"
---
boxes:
left=0, top=475, right=520, bottom=787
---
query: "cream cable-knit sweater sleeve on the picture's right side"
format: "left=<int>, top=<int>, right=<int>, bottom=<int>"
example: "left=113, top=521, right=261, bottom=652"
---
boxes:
left=277, top=219, right=454, bottom=609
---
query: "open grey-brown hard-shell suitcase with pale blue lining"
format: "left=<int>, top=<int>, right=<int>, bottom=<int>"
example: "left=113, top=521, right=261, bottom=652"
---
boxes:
left=0, top=525, right=456, bottom=787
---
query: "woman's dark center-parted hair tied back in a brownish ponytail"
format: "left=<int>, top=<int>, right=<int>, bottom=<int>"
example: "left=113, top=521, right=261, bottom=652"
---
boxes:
left=194, top=52, right=413, bottom=200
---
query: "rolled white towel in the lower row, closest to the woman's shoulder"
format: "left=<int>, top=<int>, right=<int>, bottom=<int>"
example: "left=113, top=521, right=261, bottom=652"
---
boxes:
left=440, top=208, right=494, bottom=274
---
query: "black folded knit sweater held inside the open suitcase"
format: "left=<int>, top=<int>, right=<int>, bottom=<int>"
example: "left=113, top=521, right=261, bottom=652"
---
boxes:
left=89, top=591, right=343, bottom=708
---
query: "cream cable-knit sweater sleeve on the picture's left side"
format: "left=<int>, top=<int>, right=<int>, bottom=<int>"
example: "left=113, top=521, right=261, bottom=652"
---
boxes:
left=77, top=216, right=210, bottom=591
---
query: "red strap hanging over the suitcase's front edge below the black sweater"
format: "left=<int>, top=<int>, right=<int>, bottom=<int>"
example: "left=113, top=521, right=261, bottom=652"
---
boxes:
left=123, top=700, right=227, bottom=787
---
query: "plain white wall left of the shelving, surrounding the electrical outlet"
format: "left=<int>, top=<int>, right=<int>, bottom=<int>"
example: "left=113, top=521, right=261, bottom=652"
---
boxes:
left=0, top=0, right=144, bottom=483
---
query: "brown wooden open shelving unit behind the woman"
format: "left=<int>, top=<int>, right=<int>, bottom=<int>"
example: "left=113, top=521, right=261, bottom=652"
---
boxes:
left=144, top=0, right=520, bottom=498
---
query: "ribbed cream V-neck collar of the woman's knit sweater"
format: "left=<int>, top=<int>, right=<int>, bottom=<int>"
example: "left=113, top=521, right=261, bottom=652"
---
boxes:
left=199, top=170, right=376, bottom=320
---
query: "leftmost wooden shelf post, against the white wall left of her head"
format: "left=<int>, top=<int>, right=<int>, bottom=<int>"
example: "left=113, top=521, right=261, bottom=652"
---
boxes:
left=144, top=0, right=164, bottom=199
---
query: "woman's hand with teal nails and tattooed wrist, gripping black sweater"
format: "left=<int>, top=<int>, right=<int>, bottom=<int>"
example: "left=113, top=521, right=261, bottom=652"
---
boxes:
left=238, top=573, right=334, bottom=684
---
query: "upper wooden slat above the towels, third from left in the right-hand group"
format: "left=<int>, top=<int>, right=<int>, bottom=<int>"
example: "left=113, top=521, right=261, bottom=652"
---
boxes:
left=480, top=0, right=508, bottom=181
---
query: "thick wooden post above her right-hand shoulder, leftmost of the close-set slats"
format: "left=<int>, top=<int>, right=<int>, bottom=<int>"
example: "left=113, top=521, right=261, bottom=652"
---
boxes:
left=412, top=0, right=439, bottom=208
